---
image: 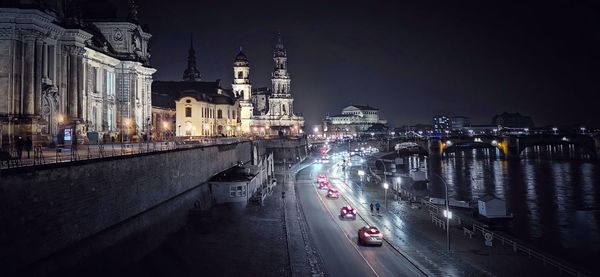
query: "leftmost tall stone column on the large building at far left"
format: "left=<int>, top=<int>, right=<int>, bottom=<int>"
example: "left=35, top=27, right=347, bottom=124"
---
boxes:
left=22, top=40, right=35, bottom=115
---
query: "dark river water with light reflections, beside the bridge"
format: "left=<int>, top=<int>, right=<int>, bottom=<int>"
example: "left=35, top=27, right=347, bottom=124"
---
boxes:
left=422, top=147, right=600, bottom=271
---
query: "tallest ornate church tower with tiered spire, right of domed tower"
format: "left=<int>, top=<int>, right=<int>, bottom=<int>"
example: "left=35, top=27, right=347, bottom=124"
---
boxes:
left=269, top=35, right=294, bottom=117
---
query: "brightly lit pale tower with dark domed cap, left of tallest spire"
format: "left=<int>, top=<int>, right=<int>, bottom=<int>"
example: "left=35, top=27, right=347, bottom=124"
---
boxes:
left=231, top=47, right=254, bottom=134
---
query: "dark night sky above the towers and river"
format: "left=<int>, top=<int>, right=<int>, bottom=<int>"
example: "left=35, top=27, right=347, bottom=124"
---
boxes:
left=138, top=0, right=600, bottom=126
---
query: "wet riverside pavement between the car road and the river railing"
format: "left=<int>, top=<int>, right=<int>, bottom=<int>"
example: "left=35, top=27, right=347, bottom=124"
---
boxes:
left=350, top=169, right=576, bottom=276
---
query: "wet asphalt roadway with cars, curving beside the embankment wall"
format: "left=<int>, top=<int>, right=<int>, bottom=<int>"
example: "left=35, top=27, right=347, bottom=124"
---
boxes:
left=295, top=155, right=423, bottom=276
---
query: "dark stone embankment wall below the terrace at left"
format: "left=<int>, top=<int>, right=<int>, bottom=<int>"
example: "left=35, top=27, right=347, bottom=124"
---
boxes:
left=0, top=142, right=252, bottom=276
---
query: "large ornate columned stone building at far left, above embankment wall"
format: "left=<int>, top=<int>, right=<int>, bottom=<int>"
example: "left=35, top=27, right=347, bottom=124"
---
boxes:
left=0, top=1, right=156, bottom=147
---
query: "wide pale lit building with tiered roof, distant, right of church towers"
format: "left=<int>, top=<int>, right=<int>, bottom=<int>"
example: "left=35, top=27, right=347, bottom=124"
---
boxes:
left=323, top=105, right=387, bottom=136
